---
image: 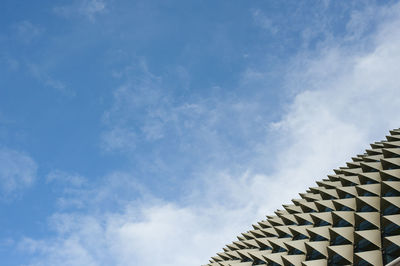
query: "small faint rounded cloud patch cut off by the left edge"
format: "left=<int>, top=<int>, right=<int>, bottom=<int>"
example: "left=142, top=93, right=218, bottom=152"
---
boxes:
left=0, top=148, right=37, bottom=201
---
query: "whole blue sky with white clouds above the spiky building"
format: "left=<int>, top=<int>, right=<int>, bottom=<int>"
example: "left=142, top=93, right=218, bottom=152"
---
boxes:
left=0, top=0, right=400, bottom=266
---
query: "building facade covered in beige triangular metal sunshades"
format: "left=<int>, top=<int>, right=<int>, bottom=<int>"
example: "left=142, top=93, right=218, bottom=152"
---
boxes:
left=206, top=129, right=400, bottom=266
